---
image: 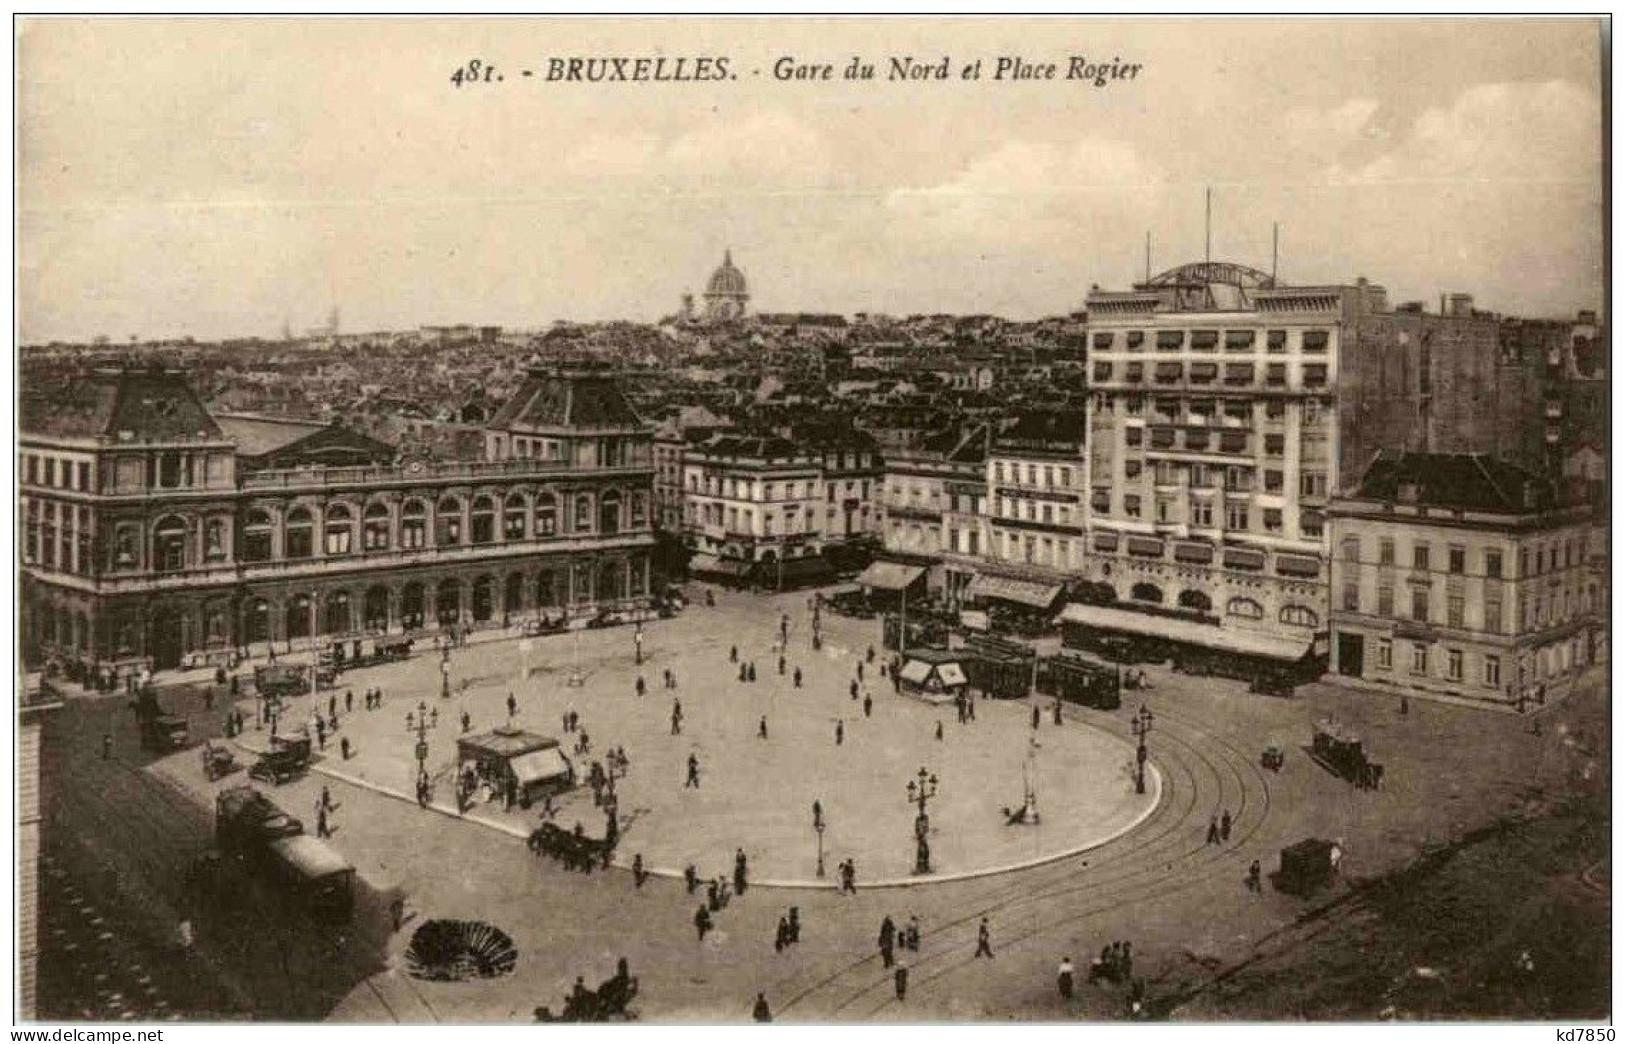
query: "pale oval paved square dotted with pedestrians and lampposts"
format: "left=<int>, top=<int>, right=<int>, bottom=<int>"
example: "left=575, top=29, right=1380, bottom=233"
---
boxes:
left=222, top=594, right=1157, bottom=886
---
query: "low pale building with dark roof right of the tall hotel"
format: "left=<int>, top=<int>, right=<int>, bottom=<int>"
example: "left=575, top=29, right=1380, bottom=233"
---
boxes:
left=1331, top=452, right=1607, bottom=711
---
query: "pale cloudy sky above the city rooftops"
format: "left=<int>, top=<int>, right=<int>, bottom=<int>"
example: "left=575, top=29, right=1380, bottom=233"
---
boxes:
left=18, top=20, right=1604, bottom=343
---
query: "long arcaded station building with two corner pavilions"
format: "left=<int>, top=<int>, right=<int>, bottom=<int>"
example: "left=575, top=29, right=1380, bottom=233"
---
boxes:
left=18, top=371, right=653, bottom=672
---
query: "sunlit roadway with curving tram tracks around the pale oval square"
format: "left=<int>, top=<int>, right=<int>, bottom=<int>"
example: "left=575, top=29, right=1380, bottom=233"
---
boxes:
left=41, top=585, right=1607, bottom=1021
